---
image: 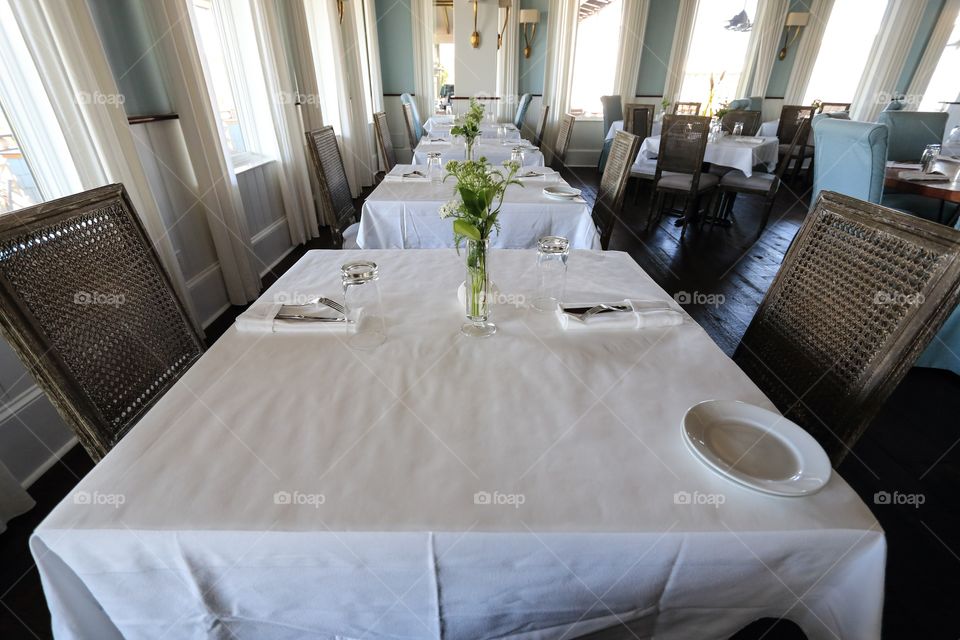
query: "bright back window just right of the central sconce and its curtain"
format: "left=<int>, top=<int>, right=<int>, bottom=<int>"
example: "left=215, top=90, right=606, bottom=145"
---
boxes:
left=570, top=0, right=623, bottom=116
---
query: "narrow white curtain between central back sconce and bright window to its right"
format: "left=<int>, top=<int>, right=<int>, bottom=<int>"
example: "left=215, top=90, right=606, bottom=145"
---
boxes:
left=542, top=0, right=579, bottom=163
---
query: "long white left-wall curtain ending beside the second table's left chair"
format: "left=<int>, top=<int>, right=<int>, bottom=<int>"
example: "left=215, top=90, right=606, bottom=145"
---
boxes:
left=253, top=0, right=319, bottom=244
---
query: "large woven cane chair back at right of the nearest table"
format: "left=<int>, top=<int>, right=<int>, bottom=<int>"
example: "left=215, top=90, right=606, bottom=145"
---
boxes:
left=734, top=191, right=960, bottom=466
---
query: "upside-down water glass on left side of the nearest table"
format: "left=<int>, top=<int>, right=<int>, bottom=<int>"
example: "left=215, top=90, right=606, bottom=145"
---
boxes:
left=340, top=260, right=387, bottom=350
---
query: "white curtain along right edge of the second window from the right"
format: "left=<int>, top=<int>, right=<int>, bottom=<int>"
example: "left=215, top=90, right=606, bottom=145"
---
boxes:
left=850, top=0, right=924, bottom=122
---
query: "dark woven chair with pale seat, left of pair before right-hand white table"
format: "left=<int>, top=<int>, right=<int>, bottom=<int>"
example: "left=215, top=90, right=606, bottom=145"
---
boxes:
left=647, top=115, right=720, bottom=238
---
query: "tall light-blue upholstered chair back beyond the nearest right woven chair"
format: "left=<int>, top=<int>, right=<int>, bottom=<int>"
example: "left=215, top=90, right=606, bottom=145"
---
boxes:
left=813, top=117, right=887, bottom=202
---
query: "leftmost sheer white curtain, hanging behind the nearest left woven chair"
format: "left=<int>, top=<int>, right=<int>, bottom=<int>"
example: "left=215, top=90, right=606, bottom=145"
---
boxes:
left=10, top=0, right=196, bottom=323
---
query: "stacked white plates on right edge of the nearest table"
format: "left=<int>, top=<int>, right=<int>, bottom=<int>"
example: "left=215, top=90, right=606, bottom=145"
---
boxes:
left=681, top=400, right=832, bottom=496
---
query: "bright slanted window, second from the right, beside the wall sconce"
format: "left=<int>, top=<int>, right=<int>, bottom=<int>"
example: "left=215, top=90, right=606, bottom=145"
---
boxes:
left=803, top=0, right=887, bottom=104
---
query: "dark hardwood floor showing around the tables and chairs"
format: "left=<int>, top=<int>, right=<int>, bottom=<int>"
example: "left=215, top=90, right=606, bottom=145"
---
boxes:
left=0, top=169, right=960, bottom=640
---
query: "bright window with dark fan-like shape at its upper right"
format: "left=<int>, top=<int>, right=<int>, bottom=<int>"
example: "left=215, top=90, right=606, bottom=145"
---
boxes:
left=680, top=0, right=757, bottom=112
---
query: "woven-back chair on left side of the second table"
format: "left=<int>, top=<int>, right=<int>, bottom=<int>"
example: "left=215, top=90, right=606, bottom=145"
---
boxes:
left=307, top=126, right=358, bottom=249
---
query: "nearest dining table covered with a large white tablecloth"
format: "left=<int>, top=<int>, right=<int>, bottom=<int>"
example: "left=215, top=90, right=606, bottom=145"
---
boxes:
left=30, top=249, right=886, bottom=640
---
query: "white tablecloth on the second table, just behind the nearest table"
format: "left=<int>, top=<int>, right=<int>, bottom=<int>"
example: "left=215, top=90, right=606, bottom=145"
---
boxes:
left=357, top=165, right=600, bottom=249
